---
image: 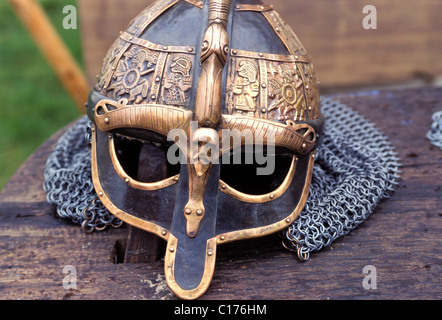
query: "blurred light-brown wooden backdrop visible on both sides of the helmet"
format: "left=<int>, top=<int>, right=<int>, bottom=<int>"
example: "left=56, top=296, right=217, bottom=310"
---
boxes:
left=78, top=0, right=442, bottom=88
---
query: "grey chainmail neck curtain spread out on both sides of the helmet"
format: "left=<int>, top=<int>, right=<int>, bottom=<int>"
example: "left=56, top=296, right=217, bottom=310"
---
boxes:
left=44, top=97, right=400, bottom=261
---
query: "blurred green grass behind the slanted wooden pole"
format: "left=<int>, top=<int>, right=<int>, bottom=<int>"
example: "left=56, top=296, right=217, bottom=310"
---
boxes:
left=0, top=0, right=82, bottom=190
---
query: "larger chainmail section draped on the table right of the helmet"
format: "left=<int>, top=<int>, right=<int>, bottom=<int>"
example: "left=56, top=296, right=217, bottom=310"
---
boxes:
left=283, top=98, right=400, bottom=261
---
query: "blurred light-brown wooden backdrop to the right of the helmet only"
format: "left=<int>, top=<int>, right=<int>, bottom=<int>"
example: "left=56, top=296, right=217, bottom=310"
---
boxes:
left=275, top=0, right=442, bottom=86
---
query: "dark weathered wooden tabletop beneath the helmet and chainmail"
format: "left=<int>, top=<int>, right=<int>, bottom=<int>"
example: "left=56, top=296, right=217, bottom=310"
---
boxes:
left=0, top=88, right=442, bottom=300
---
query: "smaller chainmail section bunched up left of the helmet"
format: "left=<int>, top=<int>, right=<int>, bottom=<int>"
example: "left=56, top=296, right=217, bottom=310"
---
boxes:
left=43, top=116, right=122, bottom=233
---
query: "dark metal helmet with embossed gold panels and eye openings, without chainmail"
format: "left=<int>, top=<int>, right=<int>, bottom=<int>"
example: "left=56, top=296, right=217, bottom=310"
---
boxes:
left=88, top=0, right=324, bottom=299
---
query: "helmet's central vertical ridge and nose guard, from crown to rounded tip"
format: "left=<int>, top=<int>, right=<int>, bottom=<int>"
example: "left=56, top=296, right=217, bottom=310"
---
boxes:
left=165, top=0, right=231, bottom=298
